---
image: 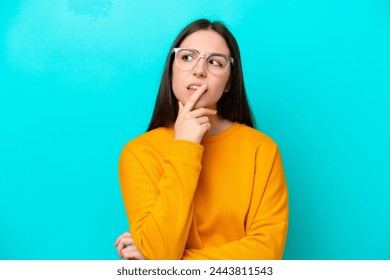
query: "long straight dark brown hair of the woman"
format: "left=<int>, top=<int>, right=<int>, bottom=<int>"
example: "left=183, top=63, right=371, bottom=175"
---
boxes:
left=148, top=19, right=254, bottom=131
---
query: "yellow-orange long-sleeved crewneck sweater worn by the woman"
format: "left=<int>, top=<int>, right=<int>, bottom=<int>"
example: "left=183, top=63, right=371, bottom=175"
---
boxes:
left=119, top=123, right=288, bottom=260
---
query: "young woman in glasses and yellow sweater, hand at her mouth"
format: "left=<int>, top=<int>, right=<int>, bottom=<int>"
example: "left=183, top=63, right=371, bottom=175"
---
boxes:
left=114, top=20, right=288, bottom=259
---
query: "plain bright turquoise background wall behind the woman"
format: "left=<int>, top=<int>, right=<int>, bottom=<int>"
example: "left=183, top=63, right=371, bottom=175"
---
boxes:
left=0, top=0, right=390, bottom=259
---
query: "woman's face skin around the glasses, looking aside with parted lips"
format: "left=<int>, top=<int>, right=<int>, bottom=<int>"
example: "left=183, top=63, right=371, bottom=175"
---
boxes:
left=172, top=30, right=231, bottom=109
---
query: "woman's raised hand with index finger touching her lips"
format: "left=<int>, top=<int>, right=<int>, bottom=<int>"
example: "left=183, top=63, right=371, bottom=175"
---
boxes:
left=175, top=85, right=217, bottom=144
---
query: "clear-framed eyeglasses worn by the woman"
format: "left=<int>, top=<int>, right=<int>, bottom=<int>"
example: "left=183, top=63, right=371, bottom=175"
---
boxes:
left=172, top=48, right=234, bottom=76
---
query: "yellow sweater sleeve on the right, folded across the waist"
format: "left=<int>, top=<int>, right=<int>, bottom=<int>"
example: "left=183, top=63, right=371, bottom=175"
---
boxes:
left=182, top=145, right=288, bottom=260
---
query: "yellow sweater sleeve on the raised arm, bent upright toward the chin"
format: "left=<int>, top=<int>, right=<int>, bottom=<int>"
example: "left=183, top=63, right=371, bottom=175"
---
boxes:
left=119, top=140, right=203, bottom=259
